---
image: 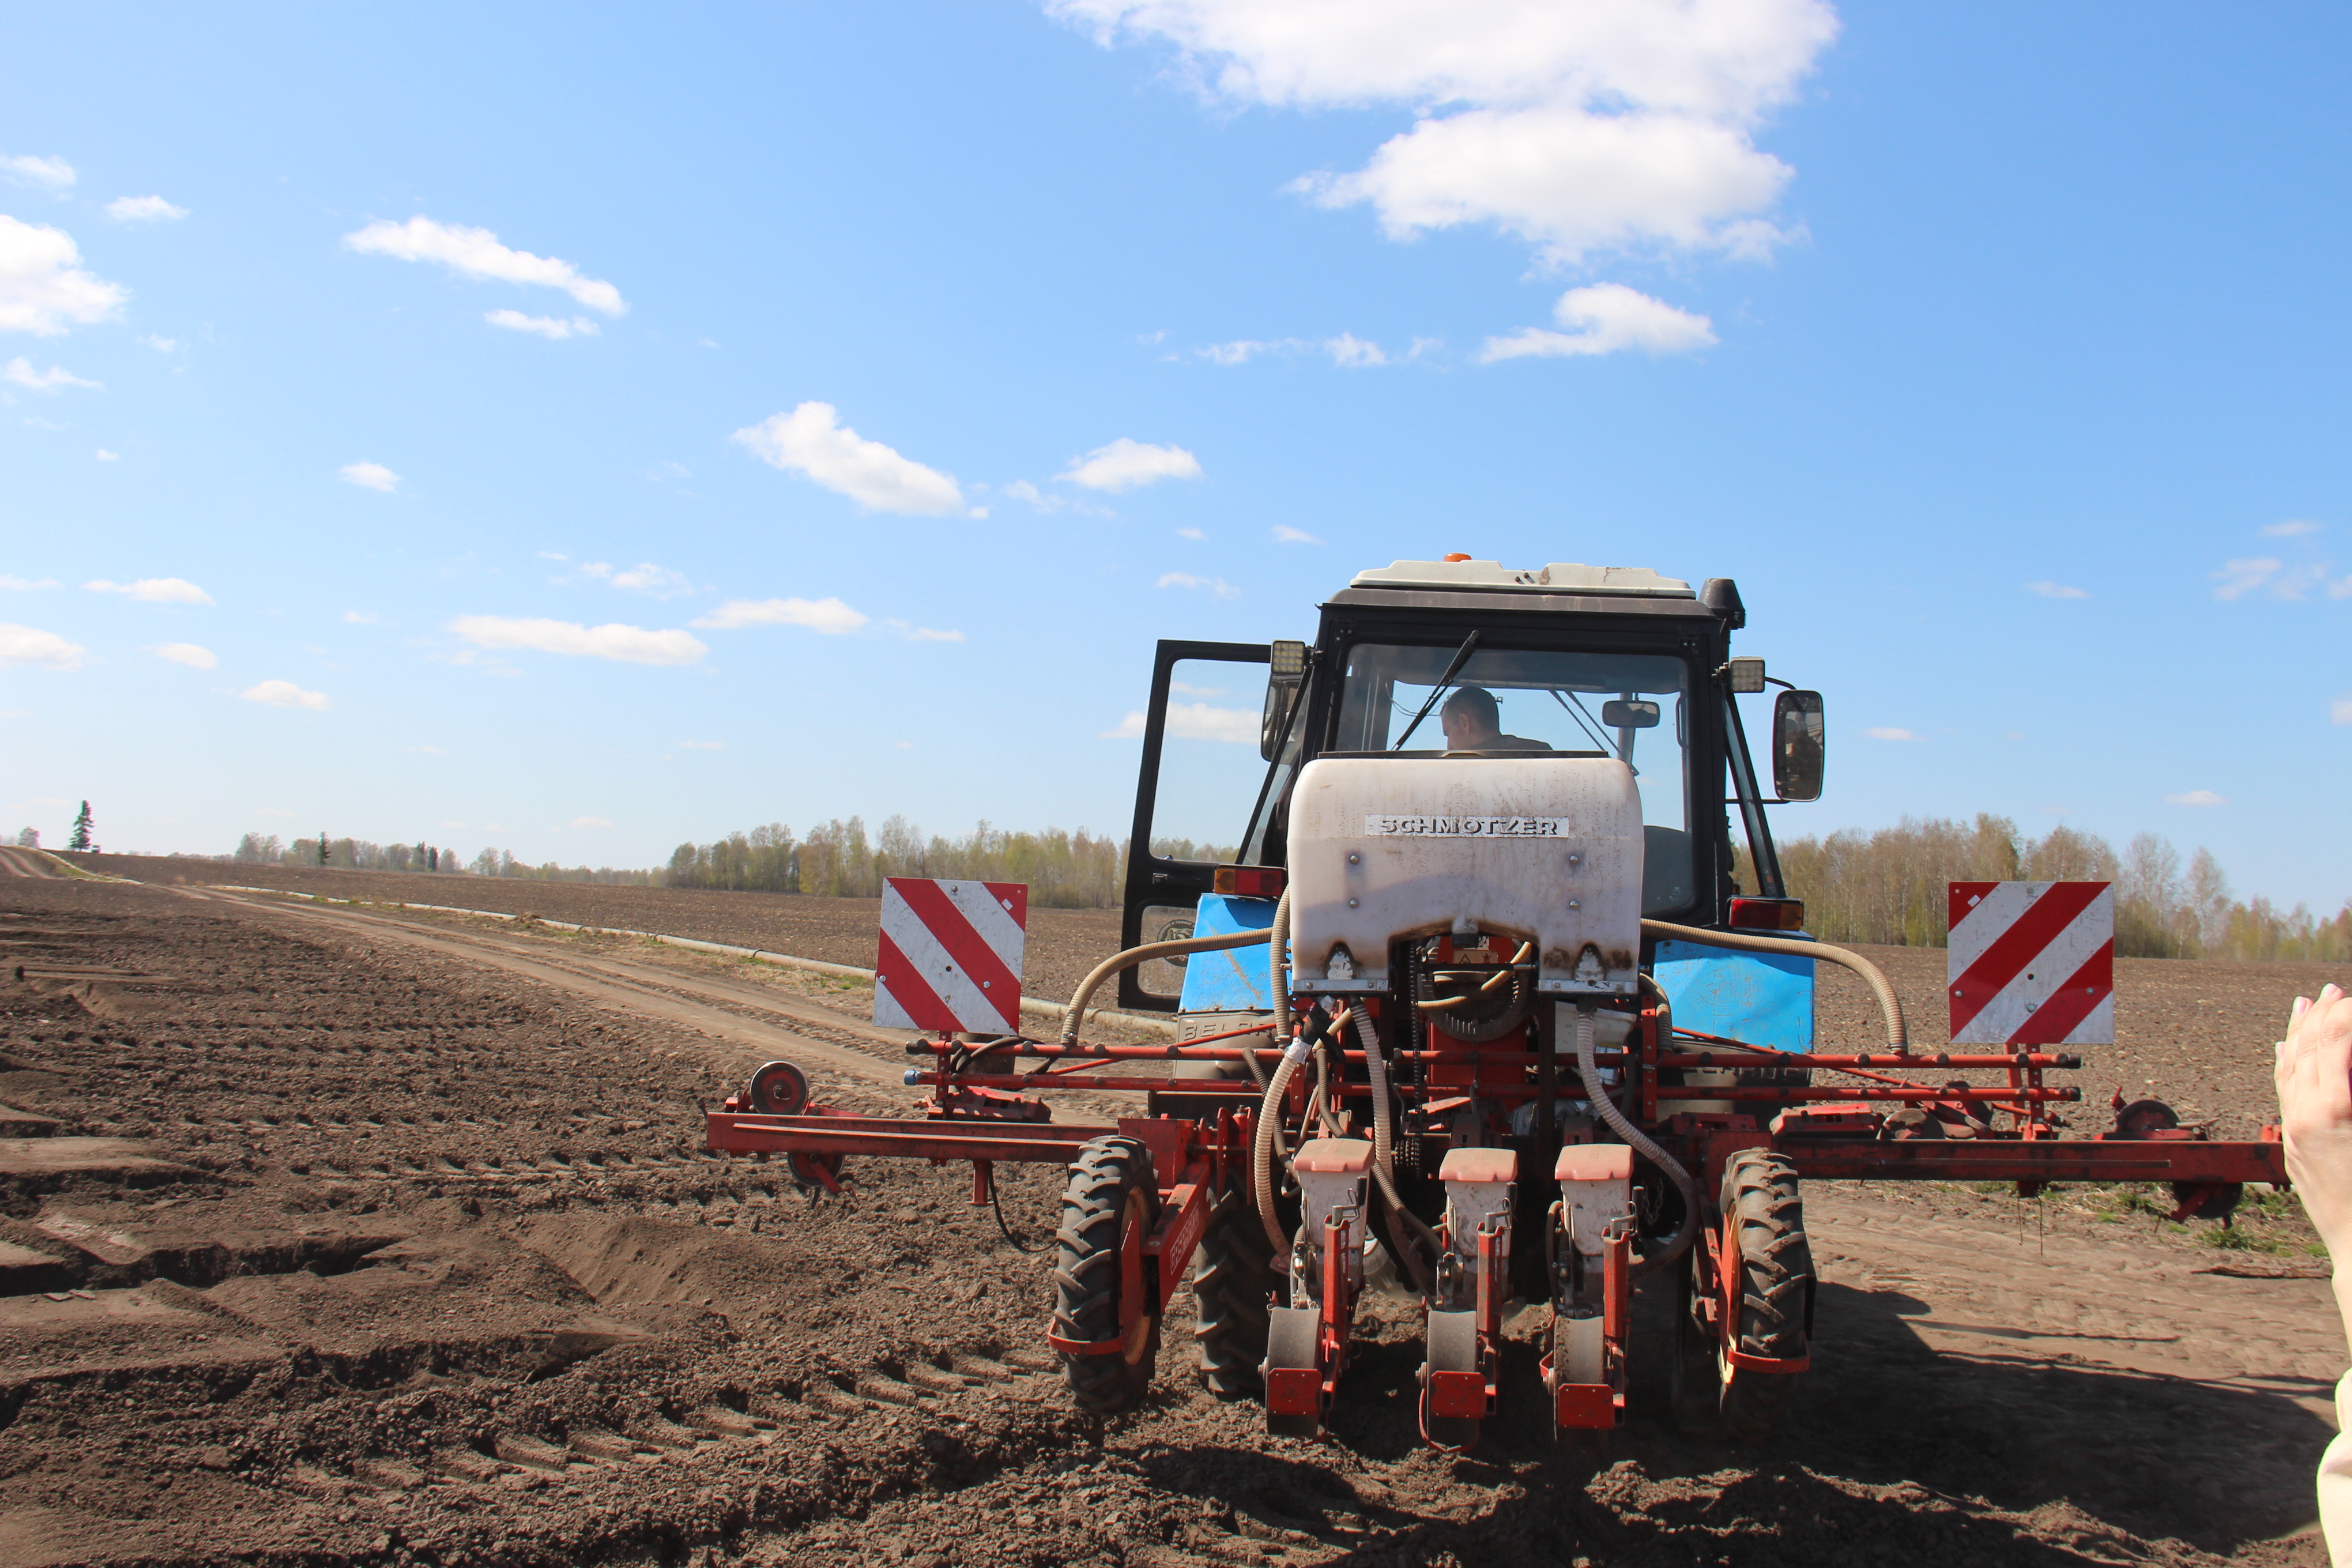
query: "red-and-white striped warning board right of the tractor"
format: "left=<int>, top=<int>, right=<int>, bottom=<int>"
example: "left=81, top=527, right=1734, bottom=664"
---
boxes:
left=1948, top=881, right=2114, bottom=1046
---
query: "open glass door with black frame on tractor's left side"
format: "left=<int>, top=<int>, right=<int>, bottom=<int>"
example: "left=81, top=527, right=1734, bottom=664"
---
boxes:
left=1120, top=642, right=1270, bottom=1013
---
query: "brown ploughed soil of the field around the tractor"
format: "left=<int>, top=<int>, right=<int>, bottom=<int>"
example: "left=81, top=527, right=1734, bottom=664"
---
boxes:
left=0, top=858, right=2345, bottom=1568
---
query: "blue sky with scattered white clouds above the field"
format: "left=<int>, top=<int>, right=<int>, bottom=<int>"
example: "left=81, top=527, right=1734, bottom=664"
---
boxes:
left=0, top=0, right=2352, bottom=910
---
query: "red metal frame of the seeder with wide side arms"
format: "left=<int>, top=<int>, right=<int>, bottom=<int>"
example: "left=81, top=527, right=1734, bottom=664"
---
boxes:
left=706, top=999, right=2286, bottom=1427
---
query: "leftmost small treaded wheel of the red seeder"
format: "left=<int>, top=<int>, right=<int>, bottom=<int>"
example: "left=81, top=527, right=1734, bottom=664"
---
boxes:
left=1054, top=1138, right=1160, bottom=1415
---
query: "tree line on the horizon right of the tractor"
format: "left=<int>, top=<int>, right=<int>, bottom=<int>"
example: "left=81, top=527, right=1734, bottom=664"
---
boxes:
left=1738, top=813, right=2352, bottom=964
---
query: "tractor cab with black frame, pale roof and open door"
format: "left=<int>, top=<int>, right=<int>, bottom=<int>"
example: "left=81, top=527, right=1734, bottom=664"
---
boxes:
left=1120, top=557, right=1823, bottom=1013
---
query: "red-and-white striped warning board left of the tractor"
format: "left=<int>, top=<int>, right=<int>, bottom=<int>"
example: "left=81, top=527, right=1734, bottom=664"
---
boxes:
left=875, top=877, right=1028, bottom=1034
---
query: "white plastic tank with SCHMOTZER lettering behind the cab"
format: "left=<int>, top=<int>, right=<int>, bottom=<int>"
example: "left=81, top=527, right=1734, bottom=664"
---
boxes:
left=1289, top=752, right=1642, bottom=997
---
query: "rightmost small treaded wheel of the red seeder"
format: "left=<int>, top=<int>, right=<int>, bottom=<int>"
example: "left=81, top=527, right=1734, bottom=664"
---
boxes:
left=1722, top=1149, right=1814, bottom=1443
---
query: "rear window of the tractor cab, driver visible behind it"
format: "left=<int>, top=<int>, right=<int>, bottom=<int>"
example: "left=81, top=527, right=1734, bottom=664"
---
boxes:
left=1331, top=642, right=1693, bottom=915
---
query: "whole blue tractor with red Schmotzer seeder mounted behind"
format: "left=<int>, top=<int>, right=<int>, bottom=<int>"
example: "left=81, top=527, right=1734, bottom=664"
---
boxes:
left=687, top=559, right=2286, bottom=1450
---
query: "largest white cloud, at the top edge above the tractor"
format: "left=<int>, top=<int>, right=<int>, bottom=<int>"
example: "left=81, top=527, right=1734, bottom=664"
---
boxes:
left=1047, top=0, right=1837, bottom=261
